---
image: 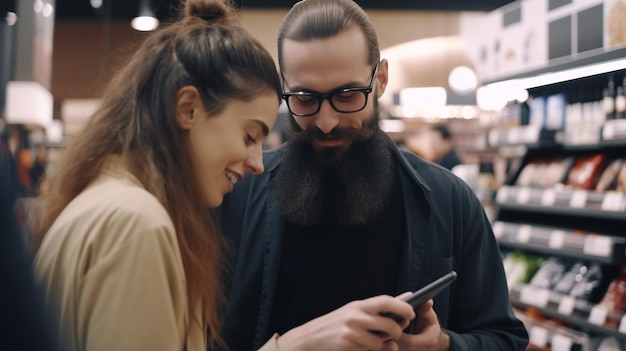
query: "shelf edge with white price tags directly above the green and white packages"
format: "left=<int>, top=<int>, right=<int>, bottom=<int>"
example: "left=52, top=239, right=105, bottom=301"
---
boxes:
left=493, top=221, right=626, bottom=264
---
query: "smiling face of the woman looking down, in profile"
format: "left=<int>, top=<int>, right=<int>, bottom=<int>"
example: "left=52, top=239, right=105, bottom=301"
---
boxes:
left=178, top=88, right=278, bottom=208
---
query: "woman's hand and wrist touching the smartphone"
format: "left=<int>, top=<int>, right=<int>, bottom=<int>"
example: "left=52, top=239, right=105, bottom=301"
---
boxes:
left=278, top=294, right=412, bottom=351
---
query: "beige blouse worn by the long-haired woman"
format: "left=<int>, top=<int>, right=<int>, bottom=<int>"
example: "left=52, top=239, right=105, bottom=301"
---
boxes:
left=34, top=156, right=277, bottom=351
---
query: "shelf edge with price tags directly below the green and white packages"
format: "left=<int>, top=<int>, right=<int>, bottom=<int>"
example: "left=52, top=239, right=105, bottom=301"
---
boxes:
left=510, top=284, right=626, bottom=341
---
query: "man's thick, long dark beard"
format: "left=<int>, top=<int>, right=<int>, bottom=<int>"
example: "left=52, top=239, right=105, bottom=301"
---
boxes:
left=270, top=114, right=394, bottom=226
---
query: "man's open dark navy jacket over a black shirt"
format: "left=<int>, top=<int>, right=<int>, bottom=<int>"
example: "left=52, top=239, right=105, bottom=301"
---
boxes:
left=219, top=144, right=528, bottom=351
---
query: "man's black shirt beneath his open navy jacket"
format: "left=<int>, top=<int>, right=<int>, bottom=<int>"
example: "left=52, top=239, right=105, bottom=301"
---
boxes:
left=266, top=185, right=405, bottom=339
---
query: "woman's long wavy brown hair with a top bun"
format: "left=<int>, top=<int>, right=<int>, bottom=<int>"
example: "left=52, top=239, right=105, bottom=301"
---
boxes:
left=29, top=0, right=281, bottom=344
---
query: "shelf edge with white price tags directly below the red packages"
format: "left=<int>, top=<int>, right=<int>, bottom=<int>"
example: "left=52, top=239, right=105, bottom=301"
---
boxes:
left=496, top=186, right=626, bottom=220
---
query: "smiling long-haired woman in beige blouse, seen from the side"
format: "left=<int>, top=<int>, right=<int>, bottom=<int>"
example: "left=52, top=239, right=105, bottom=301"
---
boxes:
left=30, top=0, right=281, bottom=351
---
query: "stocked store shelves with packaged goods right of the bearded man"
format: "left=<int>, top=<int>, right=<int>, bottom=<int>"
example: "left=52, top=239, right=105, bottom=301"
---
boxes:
left=494, top=70, right=626, bottom=351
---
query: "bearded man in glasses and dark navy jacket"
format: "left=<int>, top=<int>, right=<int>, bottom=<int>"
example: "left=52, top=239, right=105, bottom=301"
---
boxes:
left=214, top=0, right=528, bottom=351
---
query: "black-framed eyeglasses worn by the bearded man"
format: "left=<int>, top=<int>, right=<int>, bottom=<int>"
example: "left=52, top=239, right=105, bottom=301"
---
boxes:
left=283, top=65, right=378, bottom=117
